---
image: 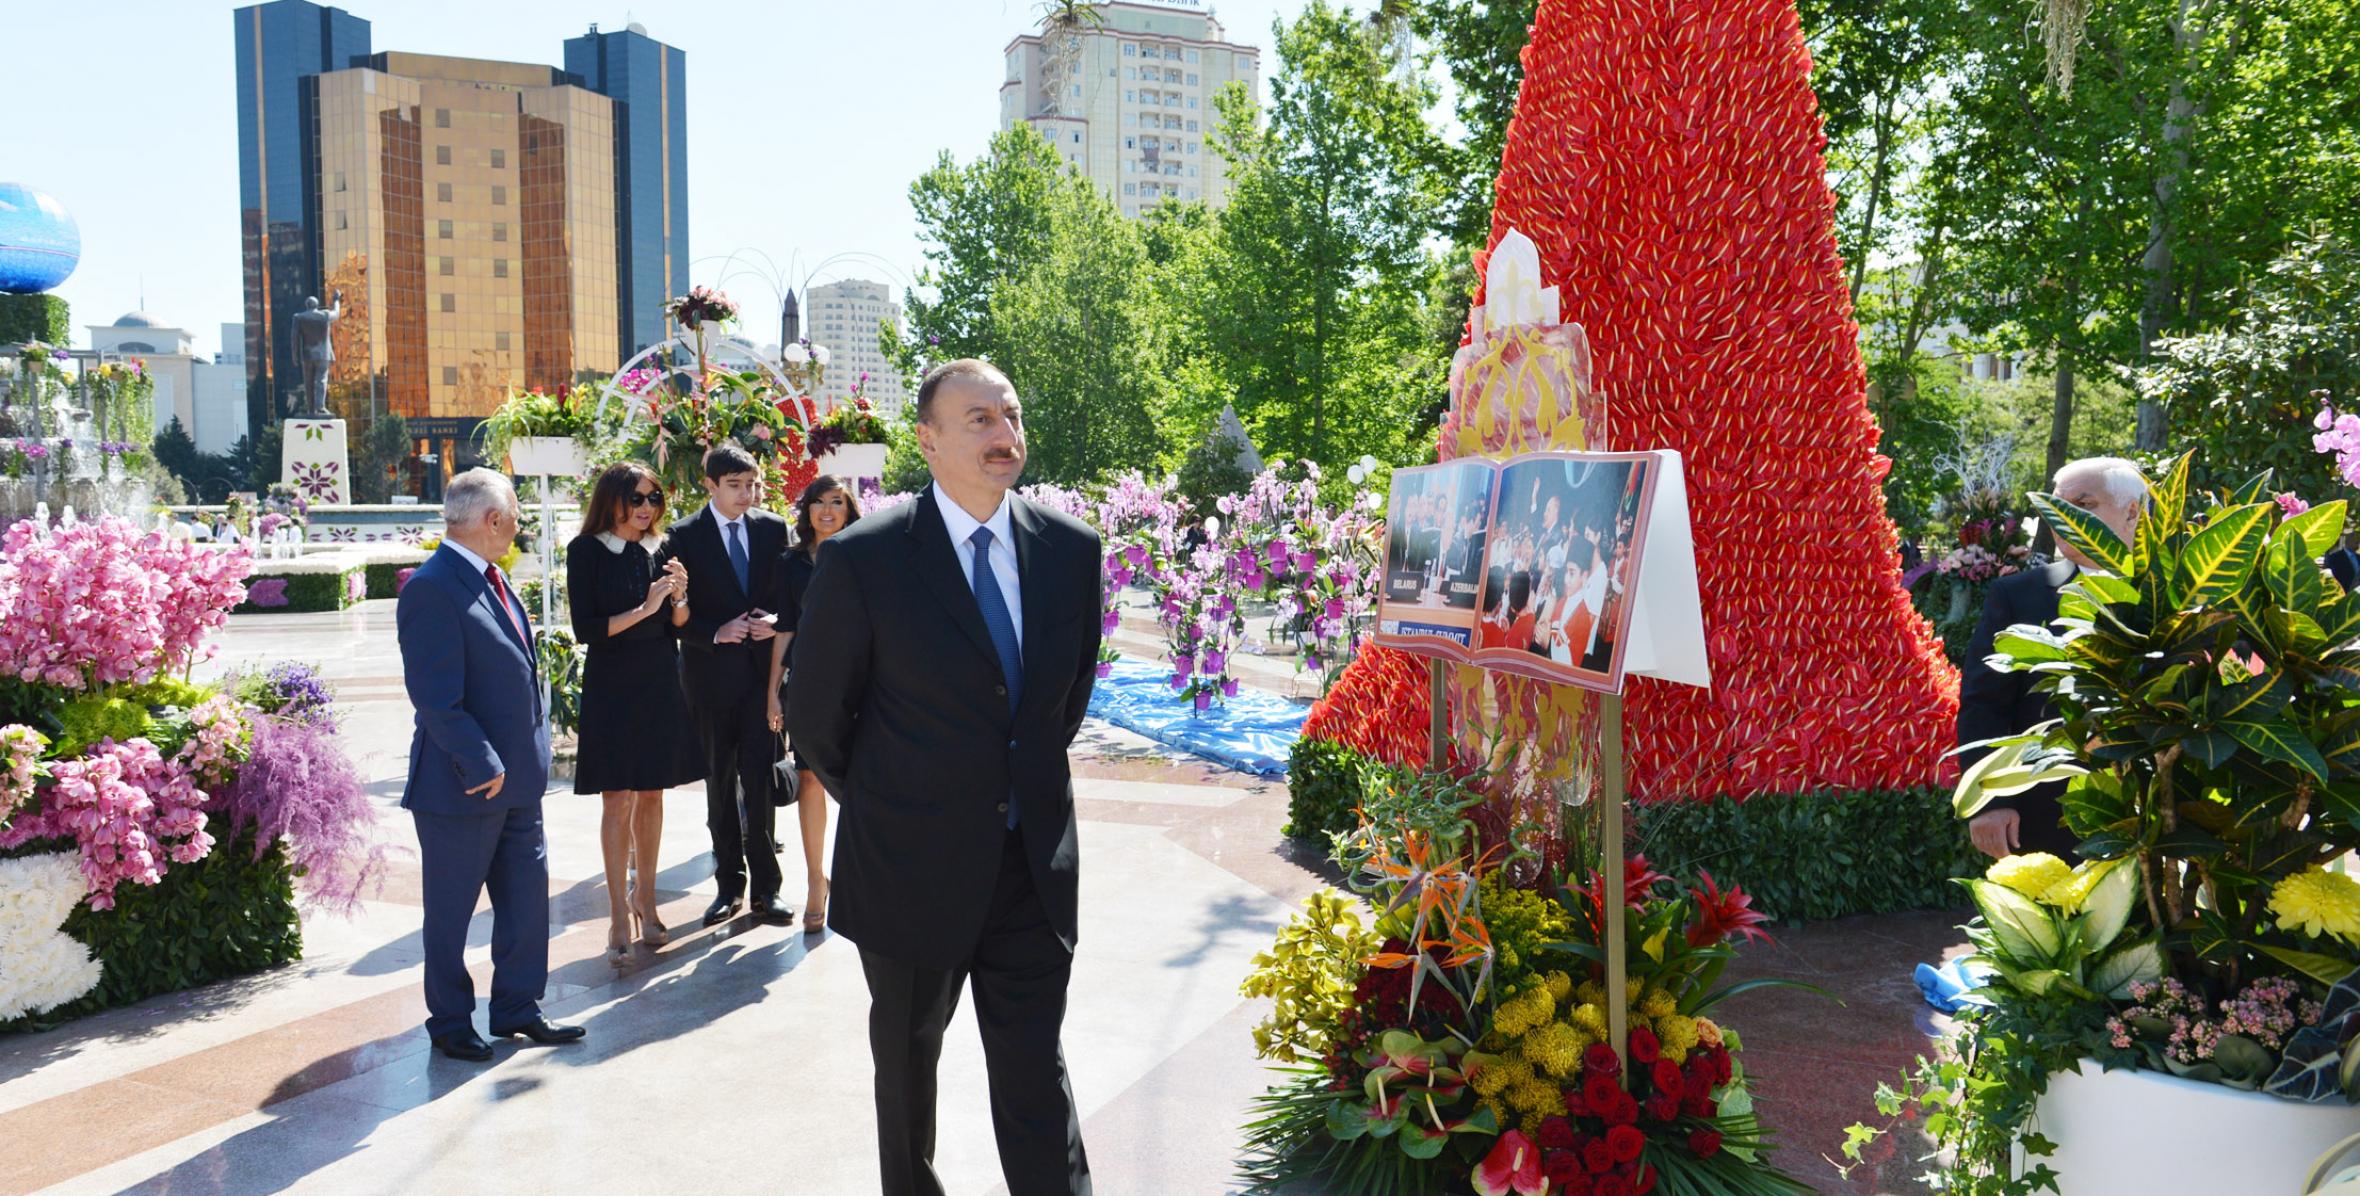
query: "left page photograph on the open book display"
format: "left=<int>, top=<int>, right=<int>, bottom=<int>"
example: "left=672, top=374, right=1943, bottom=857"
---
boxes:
left=1383, top=460, right=1492, bottom=646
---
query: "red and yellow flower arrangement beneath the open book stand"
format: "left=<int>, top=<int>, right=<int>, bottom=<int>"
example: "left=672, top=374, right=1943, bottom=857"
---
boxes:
left=1244, top=769, right=1810, bottom=1196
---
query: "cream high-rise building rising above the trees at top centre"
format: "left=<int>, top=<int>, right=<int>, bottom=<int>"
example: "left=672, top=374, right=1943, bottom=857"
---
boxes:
left=1001, top=0, right=1260, bottom=217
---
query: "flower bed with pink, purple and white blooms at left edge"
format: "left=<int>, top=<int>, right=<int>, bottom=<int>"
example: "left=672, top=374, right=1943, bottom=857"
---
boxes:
left=0, top=519, right=380, bottom=1031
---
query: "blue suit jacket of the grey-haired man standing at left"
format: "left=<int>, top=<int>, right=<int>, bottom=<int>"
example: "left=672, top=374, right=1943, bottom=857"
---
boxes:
left=394, top=547, right=550, bottom=814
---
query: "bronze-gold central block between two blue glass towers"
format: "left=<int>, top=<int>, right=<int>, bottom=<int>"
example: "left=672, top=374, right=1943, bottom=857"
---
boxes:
left=314, top=52, right=621, bottom=420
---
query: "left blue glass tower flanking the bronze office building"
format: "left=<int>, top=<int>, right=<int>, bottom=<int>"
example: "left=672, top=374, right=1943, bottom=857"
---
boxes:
left=231, top=0, right=368, bottom=429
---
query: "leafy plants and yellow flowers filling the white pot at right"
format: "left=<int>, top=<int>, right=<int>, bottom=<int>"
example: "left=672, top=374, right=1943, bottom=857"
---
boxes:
left=1883, top=458, right=2360, bottom=1191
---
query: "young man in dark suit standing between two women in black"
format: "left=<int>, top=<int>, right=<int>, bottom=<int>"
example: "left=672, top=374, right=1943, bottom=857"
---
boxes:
left=656, top=443, right=795, bottom=927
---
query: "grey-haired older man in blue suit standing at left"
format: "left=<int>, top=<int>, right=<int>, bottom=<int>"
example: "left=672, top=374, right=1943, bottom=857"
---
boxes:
left=394, top=469, right=583, bottom=1064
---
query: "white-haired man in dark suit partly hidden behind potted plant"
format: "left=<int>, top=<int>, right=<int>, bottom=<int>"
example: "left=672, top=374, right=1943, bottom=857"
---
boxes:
left=1959, top=458, right=2148, bottom=859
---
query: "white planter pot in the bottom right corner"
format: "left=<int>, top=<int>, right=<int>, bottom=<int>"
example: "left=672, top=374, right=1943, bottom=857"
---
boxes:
left=2018, top=1062, right=2360, bottom=1196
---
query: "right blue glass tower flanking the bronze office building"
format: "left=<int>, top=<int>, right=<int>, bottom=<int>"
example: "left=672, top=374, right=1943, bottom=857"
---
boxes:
left=564, top=26, right=689, bottom=359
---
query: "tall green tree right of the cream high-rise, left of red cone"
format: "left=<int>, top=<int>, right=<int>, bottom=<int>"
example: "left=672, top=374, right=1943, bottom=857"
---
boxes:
left=1199, top=0, right=1447, bottom=465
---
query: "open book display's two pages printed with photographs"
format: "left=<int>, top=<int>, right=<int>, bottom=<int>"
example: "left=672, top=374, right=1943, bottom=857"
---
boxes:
left=1376, top=453, right=1657, bottom=691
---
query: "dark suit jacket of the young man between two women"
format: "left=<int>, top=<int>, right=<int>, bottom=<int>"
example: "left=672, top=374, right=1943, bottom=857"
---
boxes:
left=654, top=505, right=786, bottom=708
